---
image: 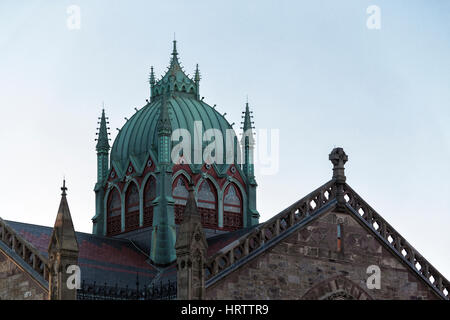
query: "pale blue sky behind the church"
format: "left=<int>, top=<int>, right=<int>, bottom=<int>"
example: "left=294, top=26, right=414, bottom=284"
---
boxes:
left=0, top=0, right=450, bottom=278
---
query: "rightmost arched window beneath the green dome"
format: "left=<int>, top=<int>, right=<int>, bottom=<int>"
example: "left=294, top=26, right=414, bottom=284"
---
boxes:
left=223, top=184, right=243, bottom=230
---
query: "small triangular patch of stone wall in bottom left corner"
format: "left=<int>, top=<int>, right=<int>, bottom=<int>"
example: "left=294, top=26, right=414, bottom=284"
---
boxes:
left=0, top=251, right=48, bottom=300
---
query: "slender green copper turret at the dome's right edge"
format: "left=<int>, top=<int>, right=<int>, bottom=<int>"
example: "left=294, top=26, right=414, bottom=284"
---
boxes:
left=241, top=101, right=259, bottom=226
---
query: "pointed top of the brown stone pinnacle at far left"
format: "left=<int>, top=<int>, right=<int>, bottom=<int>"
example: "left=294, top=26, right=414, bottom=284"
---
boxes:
left=49, top=180, right=78, bottom=252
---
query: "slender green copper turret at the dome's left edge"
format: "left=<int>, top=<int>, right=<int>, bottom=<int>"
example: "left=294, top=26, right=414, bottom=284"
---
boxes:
left=92, top=109, right=111, bottom=235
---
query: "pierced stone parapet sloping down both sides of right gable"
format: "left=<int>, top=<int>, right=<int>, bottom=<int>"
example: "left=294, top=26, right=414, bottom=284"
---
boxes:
left=206, top=179, right=450, bottom=300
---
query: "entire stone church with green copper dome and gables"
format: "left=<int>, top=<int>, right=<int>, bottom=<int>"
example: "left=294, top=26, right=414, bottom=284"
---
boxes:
left=0, top=41, right=450, bottom=300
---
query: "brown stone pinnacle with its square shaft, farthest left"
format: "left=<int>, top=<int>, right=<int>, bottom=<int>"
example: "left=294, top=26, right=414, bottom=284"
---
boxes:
left=48, top=181, right=79, bottom=300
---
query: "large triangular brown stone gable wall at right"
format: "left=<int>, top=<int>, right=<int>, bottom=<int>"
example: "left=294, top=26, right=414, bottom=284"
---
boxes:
left=206, top=212, right=439, bottom=300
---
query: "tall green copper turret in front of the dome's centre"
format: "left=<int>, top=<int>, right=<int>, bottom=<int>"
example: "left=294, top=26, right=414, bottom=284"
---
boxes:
left=150, top=97, right=176, bottom=265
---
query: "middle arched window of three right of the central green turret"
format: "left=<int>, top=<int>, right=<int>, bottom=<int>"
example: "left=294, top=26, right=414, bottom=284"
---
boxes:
left=197, top=180, right=218, bottom=228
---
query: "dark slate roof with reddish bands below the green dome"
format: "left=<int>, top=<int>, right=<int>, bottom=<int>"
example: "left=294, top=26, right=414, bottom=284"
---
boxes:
left=5, top=221, right=252, bottom=288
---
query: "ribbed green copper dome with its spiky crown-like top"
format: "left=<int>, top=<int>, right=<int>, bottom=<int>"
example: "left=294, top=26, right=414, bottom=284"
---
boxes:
left=111, top=41, right=239, bottom=175
